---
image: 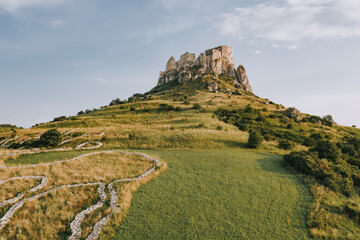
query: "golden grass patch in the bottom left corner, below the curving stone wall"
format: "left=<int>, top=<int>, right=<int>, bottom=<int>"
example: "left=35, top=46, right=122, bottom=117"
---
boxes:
left=0, top=186, right=98, bottom=240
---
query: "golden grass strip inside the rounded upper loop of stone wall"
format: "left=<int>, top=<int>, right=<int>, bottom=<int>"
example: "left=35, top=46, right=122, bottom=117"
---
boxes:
left=0, top=153, right=153, bottom=191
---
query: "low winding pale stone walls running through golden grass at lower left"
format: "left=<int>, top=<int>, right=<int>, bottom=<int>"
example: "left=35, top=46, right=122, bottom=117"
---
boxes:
left=0, top=151, right=161, bottom=240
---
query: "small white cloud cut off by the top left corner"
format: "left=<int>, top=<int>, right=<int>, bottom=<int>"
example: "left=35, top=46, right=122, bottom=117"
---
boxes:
left=0, top=0, right=69, bottom=13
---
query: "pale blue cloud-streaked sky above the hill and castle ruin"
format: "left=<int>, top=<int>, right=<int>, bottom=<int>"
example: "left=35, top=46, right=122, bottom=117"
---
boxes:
left=0, top=0, right=360, bottom=127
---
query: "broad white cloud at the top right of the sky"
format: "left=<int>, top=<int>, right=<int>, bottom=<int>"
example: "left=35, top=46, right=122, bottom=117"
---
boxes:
left=215, top=0, right=360, bottom=44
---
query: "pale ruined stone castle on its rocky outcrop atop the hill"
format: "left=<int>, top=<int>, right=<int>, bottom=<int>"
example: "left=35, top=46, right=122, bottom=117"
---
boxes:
left=158, top=46, right=252, bottom=92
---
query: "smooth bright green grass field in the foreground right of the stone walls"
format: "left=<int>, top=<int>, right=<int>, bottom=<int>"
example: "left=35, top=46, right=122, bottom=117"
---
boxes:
left=114, top=150, right=311, bottom=239
